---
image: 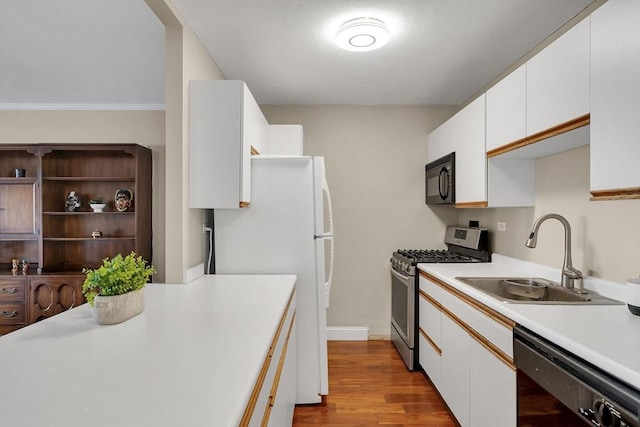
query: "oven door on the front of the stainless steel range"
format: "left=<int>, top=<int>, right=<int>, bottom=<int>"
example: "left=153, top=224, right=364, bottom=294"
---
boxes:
left=391, top=267, right=416, bottom=370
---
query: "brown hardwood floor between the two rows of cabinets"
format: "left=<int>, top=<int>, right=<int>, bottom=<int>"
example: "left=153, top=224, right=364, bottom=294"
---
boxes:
left=293, top=341, right=457, bottom=427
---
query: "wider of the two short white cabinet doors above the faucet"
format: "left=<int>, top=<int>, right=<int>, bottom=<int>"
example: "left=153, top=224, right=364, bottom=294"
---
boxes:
left=527, top=17, right=590, bottom=135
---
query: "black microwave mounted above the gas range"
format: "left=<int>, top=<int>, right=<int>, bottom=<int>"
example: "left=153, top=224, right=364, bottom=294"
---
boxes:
left=424, top=152, right=456, bottom=205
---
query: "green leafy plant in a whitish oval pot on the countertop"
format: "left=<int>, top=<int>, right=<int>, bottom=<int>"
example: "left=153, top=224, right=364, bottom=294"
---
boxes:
left=82, top=252, right=155, bottom=325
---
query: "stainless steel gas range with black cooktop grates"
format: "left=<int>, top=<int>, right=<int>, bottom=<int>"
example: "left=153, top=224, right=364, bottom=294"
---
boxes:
left=391, top=226, right=491, bottom=371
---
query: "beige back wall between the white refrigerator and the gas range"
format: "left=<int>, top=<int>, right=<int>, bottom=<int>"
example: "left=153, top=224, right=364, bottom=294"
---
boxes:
left=261, top=106, right=457, bottom=337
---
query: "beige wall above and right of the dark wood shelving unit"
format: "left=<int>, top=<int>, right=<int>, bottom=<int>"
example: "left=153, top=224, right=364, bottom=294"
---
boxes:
left=0, top=111, right=165, bottom=281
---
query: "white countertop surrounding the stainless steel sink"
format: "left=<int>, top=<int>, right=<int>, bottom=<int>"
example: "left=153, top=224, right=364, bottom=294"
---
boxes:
left=418, top=254, right=640, bottom=390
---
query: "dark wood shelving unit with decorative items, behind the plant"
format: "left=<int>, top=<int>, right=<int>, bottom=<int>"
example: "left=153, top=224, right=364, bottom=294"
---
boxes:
left=0, top=144, right=152, bottom=334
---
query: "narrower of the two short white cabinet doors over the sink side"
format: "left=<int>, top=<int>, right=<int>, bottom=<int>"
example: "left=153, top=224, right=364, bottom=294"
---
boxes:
left=487, top=64, right=527, bottom=152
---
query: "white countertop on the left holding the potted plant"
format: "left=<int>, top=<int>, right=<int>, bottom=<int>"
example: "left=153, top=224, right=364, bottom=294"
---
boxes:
left=0, top=275, right=296, bottom=427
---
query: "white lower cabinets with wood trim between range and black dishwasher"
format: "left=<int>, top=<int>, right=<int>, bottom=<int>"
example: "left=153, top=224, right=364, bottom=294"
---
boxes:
left=419, top=272, right=517, bottom=427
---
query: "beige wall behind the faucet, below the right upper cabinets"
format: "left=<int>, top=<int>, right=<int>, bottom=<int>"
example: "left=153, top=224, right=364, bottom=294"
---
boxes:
left=459, top=146, right=640, bottom=283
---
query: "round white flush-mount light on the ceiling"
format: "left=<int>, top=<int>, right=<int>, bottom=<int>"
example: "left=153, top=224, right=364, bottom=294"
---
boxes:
left=336, top=18, right=389, bottom=52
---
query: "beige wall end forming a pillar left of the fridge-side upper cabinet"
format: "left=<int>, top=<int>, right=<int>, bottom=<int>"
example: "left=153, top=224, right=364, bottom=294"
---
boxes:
left=147, top=0, right=224, bottom=283
